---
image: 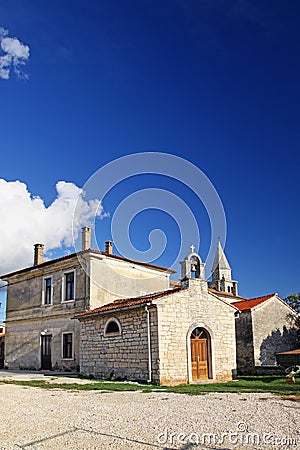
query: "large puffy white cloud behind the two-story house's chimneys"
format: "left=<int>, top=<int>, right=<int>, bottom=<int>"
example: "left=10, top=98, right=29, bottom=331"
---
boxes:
left=0, top=179, right=105, bottom=275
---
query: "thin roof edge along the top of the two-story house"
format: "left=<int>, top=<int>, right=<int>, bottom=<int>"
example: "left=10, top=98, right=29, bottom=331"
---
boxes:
left=0, top=249, right=176, bottom=281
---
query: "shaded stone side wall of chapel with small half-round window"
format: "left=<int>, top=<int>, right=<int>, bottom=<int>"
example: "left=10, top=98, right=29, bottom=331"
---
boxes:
left=80, top=305, right=159, bottom=382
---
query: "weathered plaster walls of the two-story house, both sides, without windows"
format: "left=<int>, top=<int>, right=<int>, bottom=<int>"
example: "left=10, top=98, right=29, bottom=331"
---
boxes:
left=5, top=253, right=169, bottom=376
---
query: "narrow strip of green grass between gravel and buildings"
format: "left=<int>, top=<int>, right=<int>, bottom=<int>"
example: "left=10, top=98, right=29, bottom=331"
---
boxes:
left=0, top=376, right=300, bottom=396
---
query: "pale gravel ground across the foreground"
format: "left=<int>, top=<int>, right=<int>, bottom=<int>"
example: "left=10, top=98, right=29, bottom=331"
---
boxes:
left=0, top=384, right=300, bottom=450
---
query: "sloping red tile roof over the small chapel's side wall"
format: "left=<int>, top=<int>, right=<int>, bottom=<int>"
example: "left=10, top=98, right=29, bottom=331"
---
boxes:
left=75, top=288, right=184, bottom=319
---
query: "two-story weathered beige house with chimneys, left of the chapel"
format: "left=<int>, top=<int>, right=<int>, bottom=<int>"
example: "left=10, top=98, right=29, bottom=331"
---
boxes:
left=1, top=227, right=173, bottom=370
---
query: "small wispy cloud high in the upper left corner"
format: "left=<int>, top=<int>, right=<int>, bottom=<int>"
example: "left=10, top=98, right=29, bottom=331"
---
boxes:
left=0, top=27, right=30, bottom=80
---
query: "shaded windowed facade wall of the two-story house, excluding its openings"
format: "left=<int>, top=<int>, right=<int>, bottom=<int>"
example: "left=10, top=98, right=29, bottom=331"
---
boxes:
left=5, top=258, right=88, bottom=370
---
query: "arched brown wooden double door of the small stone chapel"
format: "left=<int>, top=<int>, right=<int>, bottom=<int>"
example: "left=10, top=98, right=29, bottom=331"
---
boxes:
left=190, top=327, right=212, bottom=381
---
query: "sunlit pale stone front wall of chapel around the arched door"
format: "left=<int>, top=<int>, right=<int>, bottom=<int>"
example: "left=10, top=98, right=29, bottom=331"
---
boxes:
left=155, top=279, right=236, bottom=385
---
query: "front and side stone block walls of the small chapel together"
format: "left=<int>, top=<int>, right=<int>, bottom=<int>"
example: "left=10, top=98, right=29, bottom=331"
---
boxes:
left=80, top=279, right=236, bottom=385
